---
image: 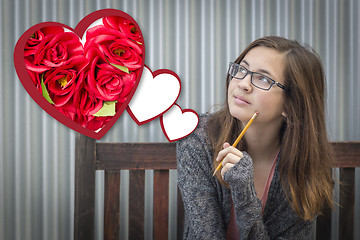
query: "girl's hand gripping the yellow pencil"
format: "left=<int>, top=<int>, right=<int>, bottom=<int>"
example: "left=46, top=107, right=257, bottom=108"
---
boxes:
left=216, top=142, right=244, bottom=178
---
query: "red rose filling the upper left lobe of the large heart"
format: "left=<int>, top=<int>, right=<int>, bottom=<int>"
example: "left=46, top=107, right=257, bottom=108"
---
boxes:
left=25, top=32, right=83, bottom=73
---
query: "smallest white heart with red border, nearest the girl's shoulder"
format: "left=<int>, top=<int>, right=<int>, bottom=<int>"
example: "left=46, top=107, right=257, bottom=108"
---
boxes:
left=160, top=104, right=199, bottom=142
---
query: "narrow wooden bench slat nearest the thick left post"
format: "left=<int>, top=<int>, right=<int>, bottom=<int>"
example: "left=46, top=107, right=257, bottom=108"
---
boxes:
left=104, top=171, right=120, bottom=240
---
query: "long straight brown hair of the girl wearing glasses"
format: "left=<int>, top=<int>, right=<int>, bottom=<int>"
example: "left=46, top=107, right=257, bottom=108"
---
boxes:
left=207, top=36, right=334, bottom=220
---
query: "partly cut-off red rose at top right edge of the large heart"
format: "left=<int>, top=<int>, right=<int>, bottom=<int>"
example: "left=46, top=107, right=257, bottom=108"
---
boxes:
left=103, top=16, right=142, bottom=44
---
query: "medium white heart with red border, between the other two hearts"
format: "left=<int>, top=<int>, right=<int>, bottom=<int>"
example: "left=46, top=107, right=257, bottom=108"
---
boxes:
left=127, top=66, right=181, bottom=125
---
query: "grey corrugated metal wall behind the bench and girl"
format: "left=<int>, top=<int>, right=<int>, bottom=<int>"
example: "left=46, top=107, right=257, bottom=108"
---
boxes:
left=0, top=0, right=360, bottom=240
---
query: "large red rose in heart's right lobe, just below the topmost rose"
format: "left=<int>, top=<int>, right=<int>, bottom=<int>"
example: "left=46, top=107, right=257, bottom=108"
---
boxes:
left=85, top=25, right=143, bottom=71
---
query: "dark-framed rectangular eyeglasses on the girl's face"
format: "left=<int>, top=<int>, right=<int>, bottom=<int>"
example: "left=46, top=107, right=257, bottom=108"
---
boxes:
left=228, top=62, right=286, bottom=91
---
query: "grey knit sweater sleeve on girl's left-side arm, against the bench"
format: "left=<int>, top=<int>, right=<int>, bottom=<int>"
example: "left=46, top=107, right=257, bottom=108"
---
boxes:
left=177, top=129, right=225, bottom=240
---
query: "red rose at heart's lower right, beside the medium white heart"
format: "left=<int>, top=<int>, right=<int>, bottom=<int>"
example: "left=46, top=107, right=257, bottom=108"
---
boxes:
left=86, top=49, right=136, bottom=103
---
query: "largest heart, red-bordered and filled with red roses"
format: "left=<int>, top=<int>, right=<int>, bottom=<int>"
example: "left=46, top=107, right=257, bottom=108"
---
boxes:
left=14, top=9, right=145, bottom=139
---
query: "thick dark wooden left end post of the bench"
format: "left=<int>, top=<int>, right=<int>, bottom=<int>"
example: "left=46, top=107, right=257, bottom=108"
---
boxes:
left=74, top=134, right=96, bottom=240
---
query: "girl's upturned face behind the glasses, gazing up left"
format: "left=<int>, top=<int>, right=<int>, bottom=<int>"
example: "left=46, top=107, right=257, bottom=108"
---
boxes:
left=228, top=46, right=285, bottom=124
